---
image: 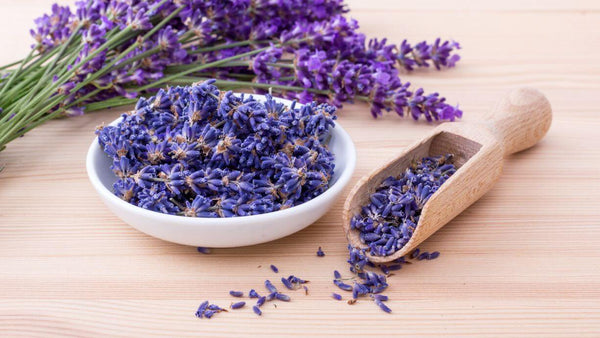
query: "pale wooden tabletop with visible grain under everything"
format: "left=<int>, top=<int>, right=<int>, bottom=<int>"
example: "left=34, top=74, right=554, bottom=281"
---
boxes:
left=0, top=0, right=600, bottom=337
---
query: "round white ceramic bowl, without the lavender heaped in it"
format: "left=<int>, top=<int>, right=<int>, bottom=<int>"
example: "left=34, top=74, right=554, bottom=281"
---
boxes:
left=86, top=95, right=356, bottom=248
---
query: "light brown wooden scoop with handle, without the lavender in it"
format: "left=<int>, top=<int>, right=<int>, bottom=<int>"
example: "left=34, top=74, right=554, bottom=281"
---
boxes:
left=342, top=88, right=552, bottom=263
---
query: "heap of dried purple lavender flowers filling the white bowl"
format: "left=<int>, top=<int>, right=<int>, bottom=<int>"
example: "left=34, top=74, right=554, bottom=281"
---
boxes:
left=97, top=80, right=336, bottom=217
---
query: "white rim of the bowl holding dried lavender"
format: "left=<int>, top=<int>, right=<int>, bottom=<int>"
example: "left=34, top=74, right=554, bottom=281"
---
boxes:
left=86, top=94, right=356, bottom=227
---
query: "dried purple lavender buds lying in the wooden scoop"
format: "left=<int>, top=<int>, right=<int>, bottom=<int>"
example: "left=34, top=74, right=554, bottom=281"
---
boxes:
left=350, top=155, right=456, bottom=256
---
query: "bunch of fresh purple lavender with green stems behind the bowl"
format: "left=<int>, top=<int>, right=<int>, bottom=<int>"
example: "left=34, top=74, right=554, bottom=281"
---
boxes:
left=0, top=0, right=462, bottom=150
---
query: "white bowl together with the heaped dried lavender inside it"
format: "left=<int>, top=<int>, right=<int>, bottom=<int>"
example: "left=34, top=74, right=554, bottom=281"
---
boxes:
left=86, top=81, right=356, bottom=247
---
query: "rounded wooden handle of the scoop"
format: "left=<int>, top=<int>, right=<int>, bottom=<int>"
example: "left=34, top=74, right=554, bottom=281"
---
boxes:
left=485, top=88, right=552, bottom=156
